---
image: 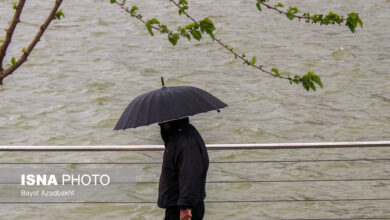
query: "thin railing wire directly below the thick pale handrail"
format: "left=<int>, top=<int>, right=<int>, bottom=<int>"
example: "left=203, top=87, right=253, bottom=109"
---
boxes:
left=0, top=158, right=390, bottom=165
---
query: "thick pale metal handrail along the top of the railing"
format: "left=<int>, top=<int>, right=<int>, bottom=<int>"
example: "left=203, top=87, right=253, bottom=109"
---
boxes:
left=0, top=141, right=390, bottom=151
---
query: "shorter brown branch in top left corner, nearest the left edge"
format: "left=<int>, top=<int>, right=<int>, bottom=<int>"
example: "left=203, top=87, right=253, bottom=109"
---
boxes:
left=0, top=0, right=25, bottom=71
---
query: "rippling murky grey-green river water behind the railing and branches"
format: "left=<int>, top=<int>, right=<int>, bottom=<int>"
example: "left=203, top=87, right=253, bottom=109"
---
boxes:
left=0, top=0, right=390, bottom=219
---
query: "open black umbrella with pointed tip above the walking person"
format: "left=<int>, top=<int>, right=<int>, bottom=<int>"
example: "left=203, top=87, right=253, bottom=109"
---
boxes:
left=114, top=77, right=227, bottom=130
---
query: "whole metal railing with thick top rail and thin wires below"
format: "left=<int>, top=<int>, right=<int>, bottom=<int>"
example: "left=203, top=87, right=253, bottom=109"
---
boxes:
left=0, top=141, right=390, bottom=219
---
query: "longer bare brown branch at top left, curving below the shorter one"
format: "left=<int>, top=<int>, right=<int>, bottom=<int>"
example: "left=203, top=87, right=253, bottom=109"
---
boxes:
left=0, top=0, right=63, bottom=85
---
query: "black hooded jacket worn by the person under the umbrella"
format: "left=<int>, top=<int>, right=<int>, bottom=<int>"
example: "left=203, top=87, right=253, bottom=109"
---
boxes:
left=158, top=118, right=209, bottom=209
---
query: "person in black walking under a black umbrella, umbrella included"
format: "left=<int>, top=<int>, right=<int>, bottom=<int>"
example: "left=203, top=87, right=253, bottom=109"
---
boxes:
left=114, top=77, right=227, bottom=220
